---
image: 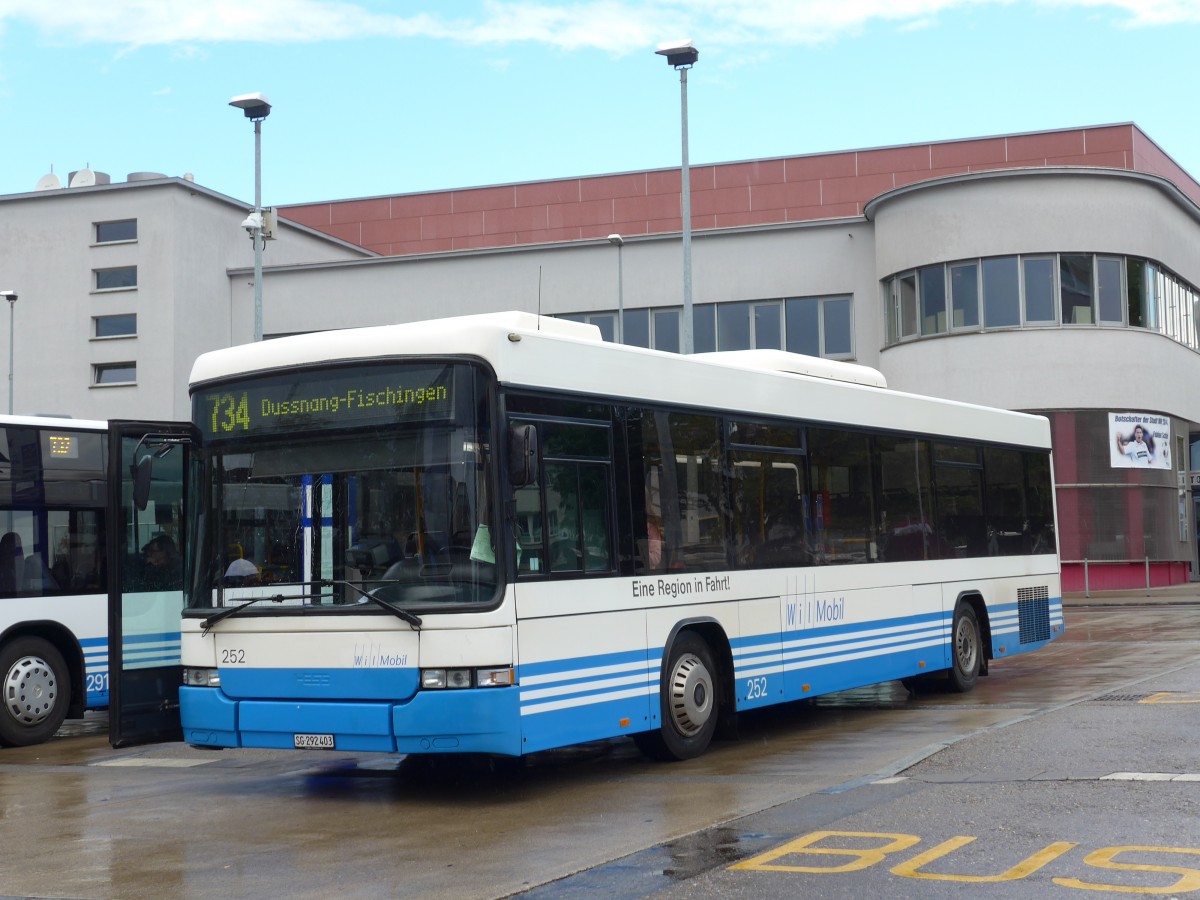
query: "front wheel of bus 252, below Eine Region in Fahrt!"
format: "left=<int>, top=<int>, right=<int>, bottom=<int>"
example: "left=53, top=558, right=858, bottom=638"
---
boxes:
left=634, top=631, right=720, bottom=762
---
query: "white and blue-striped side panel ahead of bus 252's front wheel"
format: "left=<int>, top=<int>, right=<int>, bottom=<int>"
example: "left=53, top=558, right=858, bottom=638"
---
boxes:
left=517, top=614, right=660, bottom=754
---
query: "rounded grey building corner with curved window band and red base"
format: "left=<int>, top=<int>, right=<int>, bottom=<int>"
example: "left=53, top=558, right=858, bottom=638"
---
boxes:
left=865, top=168, right=1200, bottom=589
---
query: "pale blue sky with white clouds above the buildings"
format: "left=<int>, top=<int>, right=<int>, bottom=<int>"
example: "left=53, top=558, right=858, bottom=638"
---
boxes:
left=0, top=0, right=1200, bottom=206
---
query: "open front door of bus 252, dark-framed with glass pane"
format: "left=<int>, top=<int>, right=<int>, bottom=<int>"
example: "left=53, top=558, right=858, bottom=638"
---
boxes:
left=108, top=421, right=194, bottom=746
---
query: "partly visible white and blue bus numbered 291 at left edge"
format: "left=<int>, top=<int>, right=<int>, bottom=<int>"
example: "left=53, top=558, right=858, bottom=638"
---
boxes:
left=0, top=415, right=182, bottom=746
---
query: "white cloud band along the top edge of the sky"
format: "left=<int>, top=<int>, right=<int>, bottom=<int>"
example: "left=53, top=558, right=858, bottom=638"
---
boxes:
left=0, top=0, right=1200, bottom=54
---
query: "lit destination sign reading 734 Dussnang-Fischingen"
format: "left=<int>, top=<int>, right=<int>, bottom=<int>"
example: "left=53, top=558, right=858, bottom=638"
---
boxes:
left=193, top=366, right=455, bottom=439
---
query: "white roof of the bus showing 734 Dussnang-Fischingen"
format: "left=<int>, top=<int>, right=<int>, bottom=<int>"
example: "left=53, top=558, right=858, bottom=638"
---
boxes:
left=191, top=312, right=1050, bottom=449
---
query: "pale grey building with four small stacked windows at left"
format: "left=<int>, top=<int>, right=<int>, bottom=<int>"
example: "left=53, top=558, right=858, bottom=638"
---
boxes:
left=0, top=174, right=373, bottom=419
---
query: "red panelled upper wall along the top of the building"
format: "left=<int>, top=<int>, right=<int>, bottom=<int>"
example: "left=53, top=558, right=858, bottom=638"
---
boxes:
left=281, top=125, right=1200, bottom=256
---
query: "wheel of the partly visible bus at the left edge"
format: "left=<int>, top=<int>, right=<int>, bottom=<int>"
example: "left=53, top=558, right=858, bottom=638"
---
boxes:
left=0, top=637, right=71, bottom=746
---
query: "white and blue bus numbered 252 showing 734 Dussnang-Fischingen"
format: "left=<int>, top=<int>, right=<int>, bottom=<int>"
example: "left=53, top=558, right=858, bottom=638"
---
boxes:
left=114, top=312, right=1063, bottom=760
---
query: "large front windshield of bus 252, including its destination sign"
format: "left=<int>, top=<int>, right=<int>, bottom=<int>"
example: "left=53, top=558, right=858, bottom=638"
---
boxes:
left=187, top=364, right=499, bottom=614
